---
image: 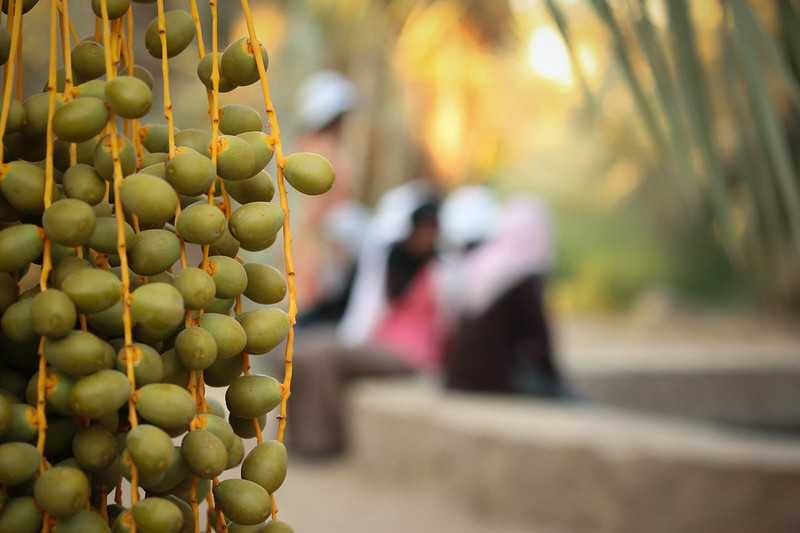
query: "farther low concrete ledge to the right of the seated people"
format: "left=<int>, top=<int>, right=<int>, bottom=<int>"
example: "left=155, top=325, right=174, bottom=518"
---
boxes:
left=557, top=318, right=800, bottom=431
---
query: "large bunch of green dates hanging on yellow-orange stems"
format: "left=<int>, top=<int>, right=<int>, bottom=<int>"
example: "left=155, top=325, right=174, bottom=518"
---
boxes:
left=0, top=0, right=334, bottom=533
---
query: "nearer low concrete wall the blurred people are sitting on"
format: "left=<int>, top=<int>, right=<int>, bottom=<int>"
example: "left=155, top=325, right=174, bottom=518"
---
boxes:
left=347, top=379, right=800, bottom=533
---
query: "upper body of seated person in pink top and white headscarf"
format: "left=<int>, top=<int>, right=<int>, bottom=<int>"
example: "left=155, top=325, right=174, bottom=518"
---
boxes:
left=338, top=179, right=444, bottom=369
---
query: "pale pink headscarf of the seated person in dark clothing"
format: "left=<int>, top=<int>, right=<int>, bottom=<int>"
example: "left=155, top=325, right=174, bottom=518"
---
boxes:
left=458, top=195, right=554, bottom=314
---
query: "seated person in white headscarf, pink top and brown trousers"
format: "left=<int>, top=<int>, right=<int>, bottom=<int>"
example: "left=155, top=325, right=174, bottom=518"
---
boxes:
left=286, top=181, right=444, bottom=456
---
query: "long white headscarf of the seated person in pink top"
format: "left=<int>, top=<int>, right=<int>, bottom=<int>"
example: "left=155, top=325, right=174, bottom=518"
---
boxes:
left=338, top=179, right=434, bottom=346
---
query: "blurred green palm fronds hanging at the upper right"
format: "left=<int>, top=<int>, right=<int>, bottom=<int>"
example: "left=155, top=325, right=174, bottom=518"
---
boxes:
left=548, top=0, right=800, bottom=308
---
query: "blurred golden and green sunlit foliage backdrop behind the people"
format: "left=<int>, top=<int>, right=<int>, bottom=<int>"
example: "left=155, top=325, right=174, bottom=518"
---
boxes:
left=14, top=0, right=800, bottom=311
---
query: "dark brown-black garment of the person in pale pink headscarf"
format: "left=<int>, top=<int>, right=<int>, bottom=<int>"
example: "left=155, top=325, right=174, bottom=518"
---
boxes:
left=445, top=275, right=561, bottom=396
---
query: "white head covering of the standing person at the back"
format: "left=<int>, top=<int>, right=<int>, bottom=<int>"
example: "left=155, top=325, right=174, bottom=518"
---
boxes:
left=297, top=70, right=356, bottom=131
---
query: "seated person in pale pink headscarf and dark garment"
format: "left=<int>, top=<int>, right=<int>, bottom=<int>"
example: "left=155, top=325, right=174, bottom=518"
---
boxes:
left=445, top=191, right=564, bottom=397
